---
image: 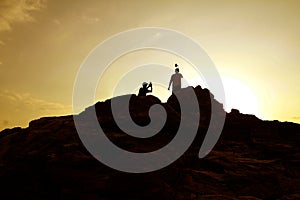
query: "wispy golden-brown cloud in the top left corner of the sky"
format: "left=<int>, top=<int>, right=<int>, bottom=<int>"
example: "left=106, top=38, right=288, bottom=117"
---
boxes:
left=0, top=0, right=46, bottom=31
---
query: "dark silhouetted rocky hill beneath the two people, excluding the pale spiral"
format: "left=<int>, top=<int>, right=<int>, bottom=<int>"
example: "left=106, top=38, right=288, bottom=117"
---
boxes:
left=0, top=86, right=300, bottom=200
